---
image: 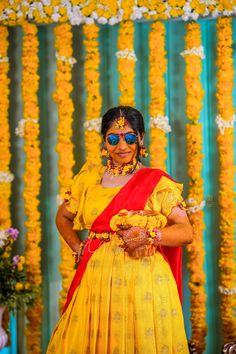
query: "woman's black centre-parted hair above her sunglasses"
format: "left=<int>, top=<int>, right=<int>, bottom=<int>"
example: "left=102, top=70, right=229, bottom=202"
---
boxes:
left=101, top=106, right=145, bottom=138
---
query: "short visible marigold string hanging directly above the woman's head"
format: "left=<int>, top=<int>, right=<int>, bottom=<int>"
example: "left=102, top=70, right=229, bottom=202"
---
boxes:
left=116, top=21, right=136, bottom=106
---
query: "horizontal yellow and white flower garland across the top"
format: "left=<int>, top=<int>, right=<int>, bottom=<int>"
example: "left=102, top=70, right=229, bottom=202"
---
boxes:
left=0, top=0, right=236, bottom=25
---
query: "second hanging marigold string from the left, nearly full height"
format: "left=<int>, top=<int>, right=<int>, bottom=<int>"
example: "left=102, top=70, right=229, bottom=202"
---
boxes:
left=22, top=24, right=43, bottom=354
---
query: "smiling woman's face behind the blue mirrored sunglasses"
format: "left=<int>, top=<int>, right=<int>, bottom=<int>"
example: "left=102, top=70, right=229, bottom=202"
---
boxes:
left=105, top=122, right=142, bottom=165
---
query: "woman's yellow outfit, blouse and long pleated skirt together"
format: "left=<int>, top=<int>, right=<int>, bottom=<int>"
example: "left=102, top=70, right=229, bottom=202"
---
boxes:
left=47, top=164, right=189, bottom=354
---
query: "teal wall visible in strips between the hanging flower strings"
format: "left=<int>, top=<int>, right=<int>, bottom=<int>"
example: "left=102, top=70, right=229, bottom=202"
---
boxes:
left=3, top=19, right=236, bottom=354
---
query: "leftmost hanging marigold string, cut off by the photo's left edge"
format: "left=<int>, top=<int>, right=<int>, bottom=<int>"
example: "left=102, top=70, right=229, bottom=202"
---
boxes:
left=0, top=26, right=13, bottom=230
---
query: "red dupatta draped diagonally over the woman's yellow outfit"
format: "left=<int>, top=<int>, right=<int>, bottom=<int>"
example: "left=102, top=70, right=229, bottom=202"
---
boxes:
left=63, top=168, right=182, bottom=312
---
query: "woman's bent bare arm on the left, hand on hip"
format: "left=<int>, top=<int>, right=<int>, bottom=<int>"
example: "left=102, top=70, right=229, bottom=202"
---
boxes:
left=56, top=202, right=81, bottom=252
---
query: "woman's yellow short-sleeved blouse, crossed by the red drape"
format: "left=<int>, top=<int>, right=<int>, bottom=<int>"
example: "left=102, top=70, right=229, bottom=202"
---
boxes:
left=66, top=163, right=183, bottom=230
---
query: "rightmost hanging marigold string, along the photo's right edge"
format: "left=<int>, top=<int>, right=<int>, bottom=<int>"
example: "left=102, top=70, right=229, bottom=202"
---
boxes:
left=216, top=18, right=236, bottom=342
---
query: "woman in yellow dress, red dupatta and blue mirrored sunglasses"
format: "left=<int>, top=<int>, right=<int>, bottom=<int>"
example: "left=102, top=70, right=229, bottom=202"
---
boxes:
left=47, top=106, right=192, bottom=354
